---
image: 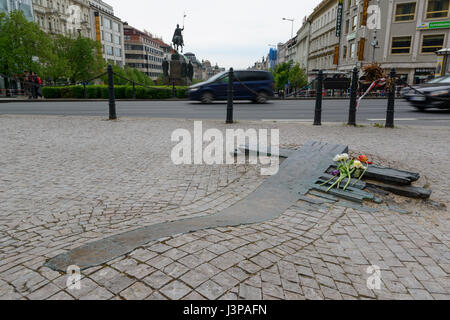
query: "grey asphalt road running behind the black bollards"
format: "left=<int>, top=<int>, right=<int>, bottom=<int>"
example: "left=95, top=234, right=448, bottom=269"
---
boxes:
left=0, top=99, right=450, bottom=126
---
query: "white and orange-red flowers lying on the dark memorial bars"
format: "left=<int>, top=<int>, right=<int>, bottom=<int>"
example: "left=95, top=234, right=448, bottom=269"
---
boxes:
left=322, top=153, right=372, bottom=192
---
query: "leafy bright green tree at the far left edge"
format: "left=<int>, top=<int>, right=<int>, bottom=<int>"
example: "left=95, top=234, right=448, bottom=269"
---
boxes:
left=0, top=11, right=51, bottom=76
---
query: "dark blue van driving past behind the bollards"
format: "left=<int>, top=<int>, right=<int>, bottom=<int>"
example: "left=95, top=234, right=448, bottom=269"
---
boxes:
left=189, top=70, right=274, bottom=103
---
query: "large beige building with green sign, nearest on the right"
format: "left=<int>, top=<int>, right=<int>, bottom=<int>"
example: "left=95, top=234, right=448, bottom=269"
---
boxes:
left=339, top=0, right=450, bottom=84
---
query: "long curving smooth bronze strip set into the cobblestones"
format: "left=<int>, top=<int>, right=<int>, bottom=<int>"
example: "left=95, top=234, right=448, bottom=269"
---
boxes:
left=45, top=141, right=348, bottom=272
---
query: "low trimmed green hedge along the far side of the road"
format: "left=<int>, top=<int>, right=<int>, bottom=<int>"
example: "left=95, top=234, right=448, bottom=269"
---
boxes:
left=42, top=85, right=187, bottom=99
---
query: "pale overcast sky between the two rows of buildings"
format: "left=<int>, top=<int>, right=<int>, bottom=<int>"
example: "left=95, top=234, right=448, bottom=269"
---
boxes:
left=104, top=0, right=320, bottom=68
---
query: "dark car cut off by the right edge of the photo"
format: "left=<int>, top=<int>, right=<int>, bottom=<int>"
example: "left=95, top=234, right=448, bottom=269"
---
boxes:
left=400, top=76, right=450, bottom=110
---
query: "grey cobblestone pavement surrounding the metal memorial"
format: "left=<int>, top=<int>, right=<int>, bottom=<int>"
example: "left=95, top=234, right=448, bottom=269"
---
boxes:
left=0, top=116, right=450, bottom=300
